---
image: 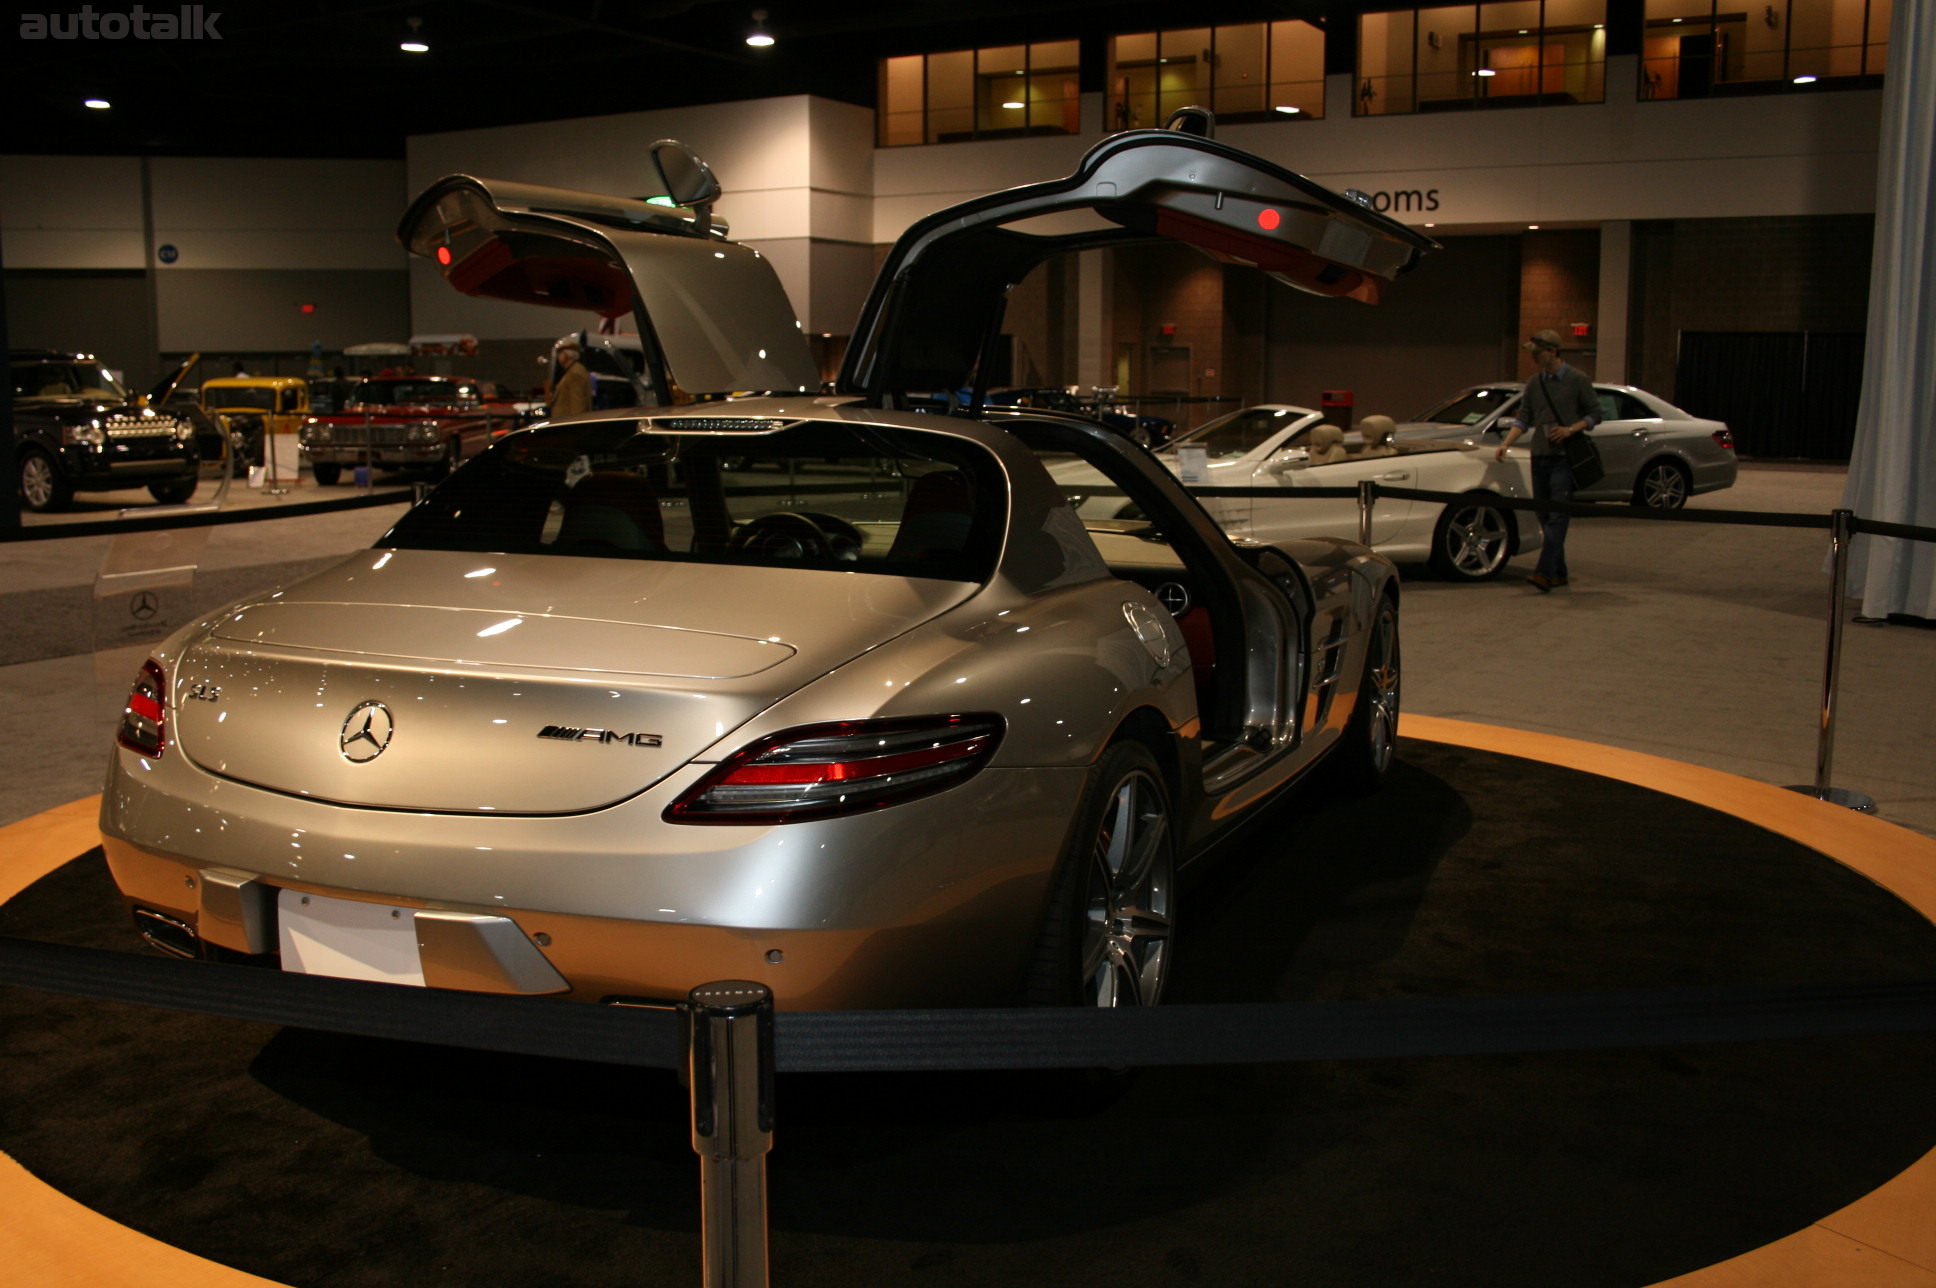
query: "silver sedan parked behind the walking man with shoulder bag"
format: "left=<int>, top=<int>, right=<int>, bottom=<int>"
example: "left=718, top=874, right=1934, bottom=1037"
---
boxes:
left=1394, top=380, right=1737, bottom=509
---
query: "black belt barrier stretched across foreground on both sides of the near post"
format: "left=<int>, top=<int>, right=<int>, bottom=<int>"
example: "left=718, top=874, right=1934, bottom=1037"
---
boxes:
left=0, top=935, right=1936, bottom=1073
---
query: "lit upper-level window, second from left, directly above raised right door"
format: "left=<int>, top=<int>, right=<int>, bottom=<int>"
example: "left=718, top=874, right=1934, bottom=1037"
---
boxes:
left=1107, top=21, right=1324, bottom=130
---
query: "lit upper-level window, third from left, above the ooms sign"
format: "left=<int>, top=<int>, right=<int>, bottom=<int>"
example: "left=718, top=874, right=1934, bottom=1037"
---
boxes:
left=1353, top=0, right=1607, bottom=116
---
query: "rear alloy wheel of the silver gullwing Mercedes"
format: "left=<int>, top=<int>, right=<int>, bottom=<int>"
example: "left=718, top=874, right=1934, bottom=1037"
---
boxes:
left=1080, top=769, right=1175, bottom=1007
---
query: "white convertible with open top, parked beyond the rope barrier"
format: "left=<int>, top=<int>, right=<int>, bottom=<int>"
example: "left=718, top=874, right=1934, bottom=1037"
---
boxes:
left=1055, top=403, right=1539, bottom=581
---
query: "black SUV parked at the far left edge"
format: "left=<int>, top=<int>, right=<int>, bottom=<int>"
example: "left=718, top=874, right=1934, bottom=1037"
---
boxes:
left=8, top=349, right=201, bottom=511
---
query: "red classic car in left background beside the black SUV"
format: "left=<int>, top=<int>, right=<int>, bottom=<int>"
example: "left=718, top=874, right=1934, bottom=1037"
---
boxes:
left=302, top=376, right=519, bottom=486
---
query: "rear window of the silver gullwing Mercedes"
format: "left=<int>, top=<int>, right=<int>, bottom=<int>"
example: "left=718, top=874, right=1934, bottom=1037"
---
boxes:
left=379, top=420, right=1007, bottom=581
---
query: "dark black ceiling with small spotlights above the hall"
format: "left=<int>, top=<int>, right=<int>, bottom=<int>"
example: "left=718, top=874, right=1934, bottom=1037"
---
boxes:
left=0, top=0, right=1331, bottom=157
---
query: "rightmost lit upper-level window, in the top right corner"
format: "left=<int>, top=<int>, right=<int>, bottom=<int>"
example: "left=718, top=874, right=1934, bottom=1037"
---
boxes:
left=1640, top=0, right=1890, bottom=99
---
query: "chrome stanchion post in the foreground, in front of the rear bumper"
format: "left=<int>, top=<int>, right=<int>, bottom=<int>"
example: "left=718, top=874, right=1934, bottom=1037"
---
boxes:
left=685, top=980, right=772, bottom=1288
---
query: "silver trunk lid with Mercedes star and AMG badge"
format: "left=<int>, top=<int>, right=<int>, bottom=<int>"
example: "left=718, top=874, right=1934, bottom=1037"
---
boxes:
left=174, top=550, right=976, bottom=813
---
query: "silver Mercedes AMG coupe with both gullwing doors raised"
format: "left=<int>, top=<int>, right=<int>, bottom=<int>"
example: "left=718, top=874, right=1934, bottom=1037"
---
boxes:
left=101, top=130, right=1433, bottom=1009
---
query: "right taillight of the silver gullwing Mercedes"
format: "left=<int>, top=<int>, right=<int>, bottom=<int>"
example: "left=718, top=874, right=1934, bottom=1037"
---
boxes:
left=666, top=715, right=1005, bottom=823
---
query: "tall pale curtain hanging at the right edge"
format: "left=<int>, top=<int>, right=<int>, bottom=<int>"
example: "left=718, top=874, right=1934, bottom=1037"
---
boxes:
left=1843, top=0, right=1936, bottom=618
